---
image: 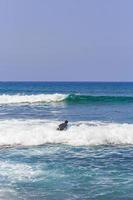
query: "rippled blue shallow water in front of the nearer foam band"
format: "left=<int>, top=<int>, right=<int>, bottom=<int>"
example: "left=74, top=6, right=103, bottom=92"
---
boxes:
left=0, top=144, right=133, bottom=199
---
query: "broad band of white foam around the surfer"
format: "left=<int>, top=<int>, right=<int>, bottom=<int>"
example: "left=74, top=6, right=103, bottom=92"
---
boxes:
left=0, top=120, right=133, bottom=146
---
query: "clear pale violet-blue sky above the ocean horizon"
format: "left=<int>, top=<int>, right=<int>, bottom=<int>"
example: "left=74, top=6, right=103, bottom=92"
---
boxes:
left=0, top=0, right=133, bottom=81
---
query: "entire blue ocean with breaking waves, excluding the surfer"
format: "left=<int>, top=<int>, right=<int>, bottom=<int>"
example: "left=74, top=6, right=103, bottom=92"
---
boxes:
left=0, top=82, right=133, bottom=200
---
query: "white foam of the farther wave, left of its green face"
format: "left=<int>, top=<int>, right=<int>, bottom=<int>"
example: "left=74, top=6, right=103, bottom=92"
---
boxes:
left=0, top=93, right=68, bottom=104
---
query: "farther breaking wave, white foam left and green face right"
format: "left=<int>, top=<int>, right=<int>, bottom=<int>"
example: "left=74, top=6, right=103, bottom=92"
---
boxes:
left=0, top=93, right=133, bottom=104
